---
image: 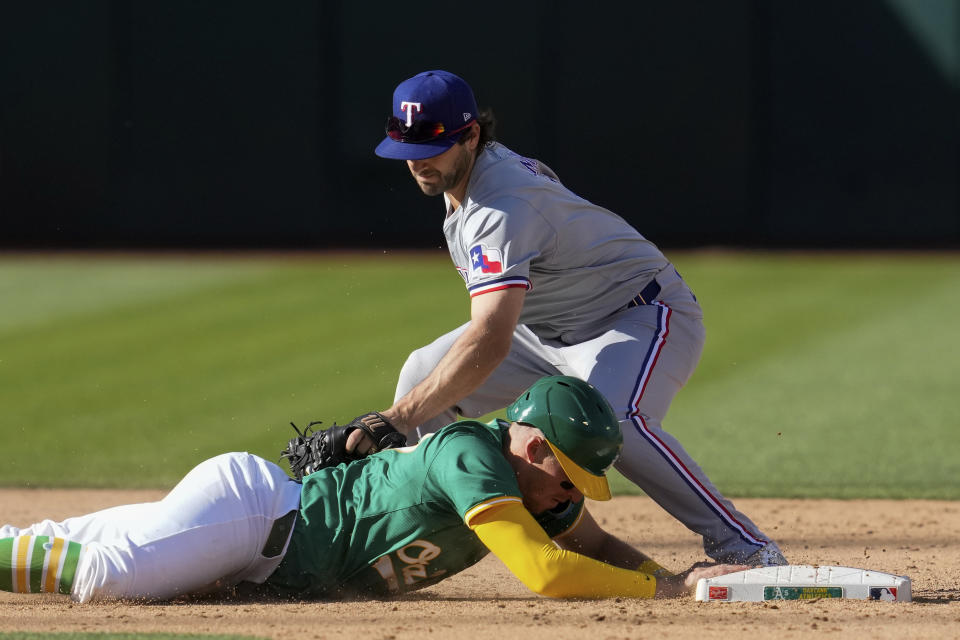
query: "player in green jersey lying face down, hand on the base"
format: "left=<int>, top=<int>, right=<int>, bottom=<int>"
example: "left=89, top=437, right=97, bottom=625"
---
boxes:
left=0, top=376, right=744, bottom=602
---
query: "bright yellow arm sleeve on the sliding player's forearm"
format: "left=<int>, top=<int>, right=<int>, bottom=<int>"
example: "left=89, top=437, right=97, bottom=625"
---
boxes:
left=467, top=502, right=657, bottom=598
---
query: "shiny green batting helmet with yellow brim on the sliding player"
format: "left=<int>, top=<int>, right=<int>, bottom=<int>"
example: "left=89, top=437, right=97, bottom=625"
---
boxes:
left=507, top=376, right=623, bottom=500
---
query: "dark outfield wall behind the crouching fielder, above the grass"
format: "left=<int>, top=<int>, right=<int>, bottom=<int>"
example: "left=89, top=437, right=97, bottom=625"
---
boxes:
left=0, top=0, right=960, bottom=248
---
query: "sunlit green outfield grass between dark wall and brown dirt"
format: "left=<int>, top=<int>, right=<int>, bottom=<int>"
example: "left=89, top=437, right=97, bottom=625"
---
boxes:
left=0, top=252, right=960, bottom=499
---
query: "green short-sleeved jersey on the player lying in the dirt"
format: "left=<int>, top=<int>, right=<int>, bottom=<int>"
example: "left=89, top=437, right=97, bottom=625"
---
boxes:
left=266, top=420, right=583, bottom=599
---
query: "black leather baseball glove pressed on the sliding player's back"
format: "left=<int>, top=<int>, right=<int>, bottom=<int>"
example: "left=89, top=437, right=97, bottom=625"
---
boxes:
left=280, top=411, right=407, bottom=480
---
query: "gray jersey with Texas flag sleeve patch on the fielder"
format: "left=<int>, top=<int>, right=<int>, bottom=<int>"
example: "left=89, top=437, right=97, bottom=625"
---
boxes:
left=443, top=144, right=668, bottom=338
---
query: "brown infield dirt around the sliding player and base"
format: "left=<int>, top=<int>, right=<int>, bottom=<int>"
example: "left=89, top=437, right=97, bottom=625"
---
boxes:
left=0, top=489, right=960, bottom=640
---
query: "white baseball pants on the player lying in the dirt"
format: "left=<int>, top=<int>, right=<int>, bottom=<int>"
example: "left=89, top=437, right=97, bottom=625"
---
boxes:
left=0, top=453, right=300, bottom=602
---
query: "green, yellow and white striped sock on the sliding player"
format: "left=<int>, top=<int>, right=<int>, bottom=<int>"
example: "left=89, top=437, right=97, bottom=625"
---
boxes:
left=0, top=536, right=83, bottom=594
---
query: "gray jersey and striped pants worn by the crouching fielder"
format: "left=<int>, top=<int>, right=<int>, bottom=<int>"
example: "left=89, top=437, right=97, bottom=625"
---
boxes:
left=396, top=144, right=775, bottom=562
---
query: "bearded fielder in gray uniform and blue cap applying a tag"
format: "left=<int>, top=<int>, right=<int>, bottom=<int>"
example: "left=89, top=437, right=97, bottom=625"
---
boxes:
left=370, top=71, right=787, bottom=565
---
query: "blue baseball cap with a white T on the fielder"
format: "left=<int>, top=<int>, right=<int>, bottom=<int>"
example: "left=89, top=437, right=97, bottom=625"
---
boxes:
left=376, top=70, right=477, bottom=160
